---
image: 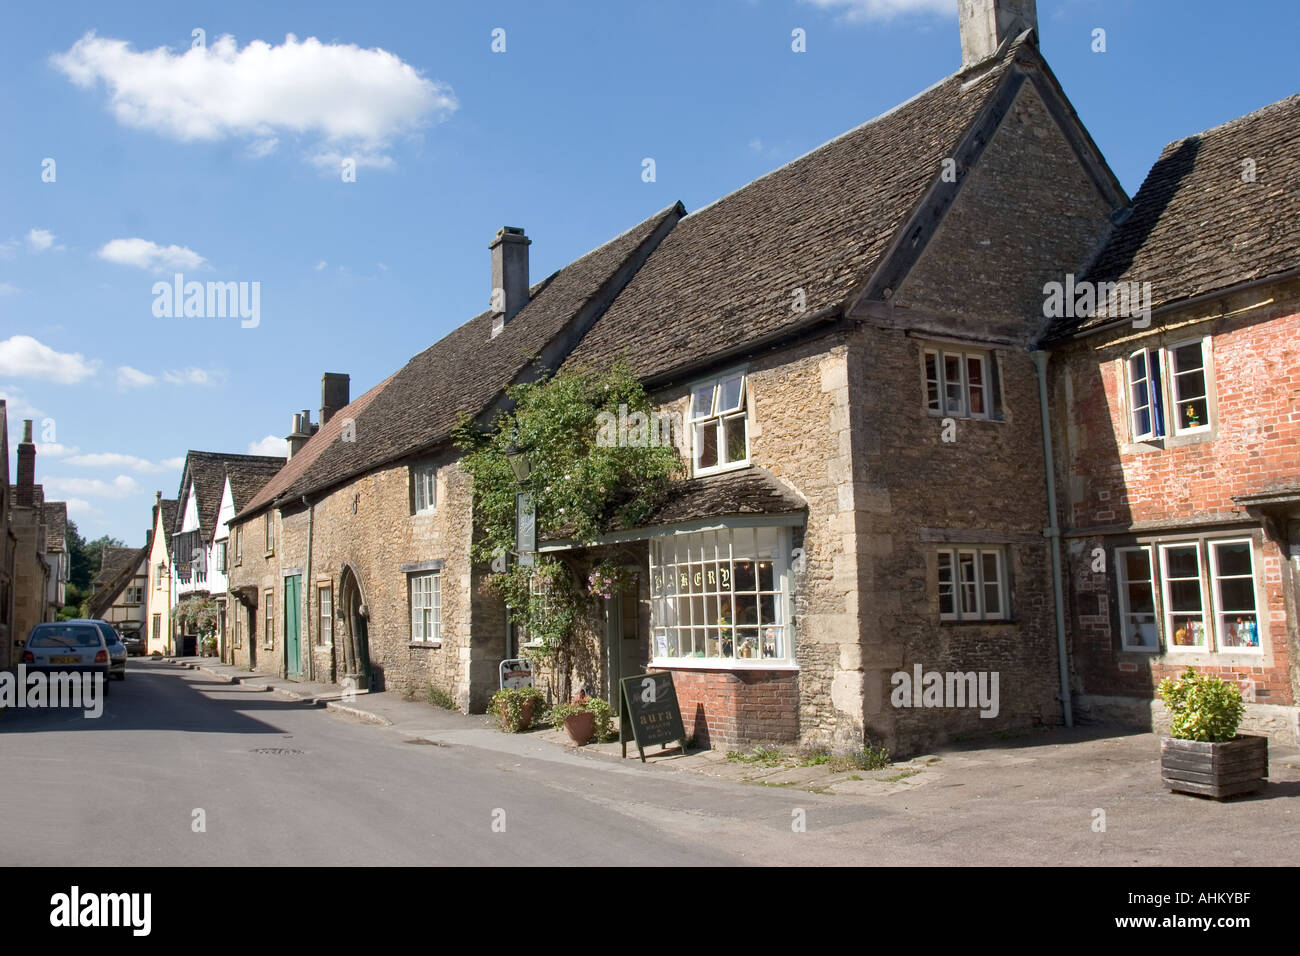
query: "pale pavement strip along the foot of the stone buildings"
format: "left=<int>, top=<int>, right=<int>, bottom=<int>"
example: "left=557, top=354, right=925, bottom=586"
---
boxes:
left=168, top=658, right=1300, bottom=797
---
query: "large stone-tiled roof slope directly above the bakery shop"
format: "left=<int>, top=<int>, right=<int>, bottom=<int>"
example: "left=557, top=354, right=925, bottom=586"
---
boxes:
left=568, top=43, right=1031, bottom=377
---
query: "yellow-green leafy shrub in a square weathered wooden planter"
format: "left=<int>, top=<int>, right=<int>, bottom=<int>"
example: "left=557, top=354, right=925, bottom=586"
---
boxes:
left=1160, top=667, right=1269, bottom=800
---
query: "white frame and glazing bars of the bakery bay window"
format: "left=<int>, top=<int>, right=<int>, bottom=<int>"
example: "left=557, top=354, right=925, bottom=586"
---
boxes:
left=650, top=525, right=798, bottom=670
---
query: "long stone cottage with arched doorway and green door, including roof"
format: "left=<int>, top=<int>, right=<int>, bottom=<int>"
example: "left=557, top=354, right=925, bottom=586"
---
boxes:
left=229, top=204, right=683, bottom=710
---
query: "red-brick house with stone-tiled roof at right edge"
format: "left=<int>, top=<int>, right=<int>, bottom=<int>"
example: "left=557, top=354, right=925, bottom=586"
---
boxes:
left=1048, top=96, right=1300, bottom=744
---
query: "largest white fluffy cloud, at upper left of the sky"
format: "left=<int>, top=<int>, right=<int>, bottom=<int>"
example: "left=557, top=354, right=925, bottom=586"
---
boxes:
left=51, top=31, right=459, bottom=164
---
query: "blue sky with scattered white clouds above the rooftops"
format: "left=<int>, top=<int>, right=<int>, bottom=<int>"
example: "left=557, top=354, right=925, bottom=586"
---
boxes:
left=0, top=0, right=1300, bottom=544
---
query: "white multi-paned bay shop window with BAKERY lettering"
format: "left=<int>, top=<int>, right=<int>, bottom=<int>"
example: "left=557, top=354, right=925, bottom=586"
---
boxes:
left=650, top=527, right=794, bottom=669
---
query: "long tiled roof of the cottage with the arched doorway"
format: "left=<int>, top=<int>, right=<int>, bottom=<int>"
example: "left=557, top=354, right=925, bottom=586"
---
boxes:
left=256, top=203, right=681, bottom=512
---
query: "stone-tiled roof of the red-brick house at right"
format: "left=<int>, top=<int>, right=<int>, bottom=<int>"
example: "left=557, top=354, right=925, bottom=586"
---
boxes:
left=1052, top=94, right=1300, bottom=339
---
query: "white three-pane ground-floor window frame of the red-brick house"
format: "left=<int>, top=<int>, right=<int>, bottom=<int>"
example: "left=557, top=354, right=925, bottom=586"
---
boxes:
left=1108, top=528, right=1273, bottom=658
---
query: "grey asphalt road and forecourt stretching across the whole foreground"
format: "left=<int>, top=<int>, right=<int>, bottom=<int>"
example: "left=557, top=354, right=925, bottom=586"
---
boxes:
left=0, top=661, right=1300, bottom=866
